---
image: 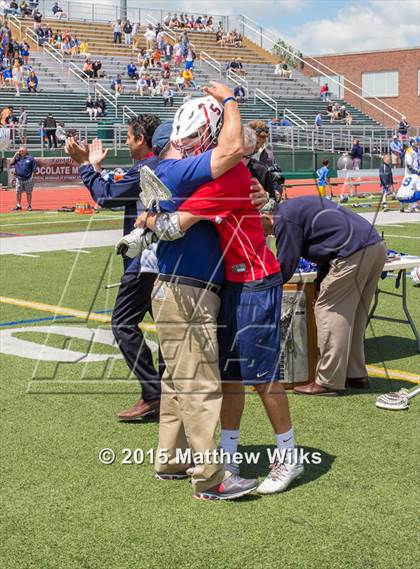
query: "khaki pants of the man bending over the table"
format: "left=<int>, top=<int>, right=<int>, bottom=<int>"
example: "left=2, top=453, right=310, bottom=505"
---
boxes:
left=315, top=242, right=386, bottom=389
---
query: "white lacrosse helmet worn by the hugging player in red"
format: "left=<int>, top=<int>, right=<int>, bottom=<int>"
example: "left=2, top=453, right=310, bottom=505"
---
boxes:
left=171, top=96, right=223, bottom=156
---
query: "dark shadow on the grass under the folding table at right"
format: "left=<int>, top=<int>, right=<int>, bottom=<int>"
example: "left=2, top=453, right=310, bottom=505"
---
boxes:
left=365, top=336, right=418, bottom=365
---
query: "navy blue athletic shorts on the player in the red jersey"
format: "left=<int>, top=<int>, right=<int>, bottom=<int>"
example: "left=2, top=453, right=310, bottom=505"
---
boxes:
left=217, top=273, right=283, bottom=385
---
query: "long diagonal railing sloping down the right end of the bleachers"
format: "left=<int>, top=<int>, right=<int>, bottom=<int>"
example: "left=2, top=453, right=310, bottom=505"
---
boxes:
left=237, top=14, right=401, bottom=127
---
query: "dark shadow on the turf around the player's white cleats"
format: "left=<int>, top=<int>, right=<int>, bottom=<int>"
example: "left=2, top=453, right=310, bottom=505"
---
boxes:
left=239, top=445, right=336, bottom=488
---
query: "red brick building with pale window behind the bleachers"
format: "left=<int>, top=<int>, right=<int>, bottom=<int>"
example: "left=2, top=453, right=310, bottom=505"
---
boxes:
left=301, top=47, right=420, bottom=126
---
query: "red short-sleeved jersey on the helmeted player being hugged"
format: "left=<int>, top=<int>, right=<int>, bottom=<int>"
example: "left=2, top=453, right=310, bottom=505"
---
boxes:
left=178, top=162, right=280, bottom=283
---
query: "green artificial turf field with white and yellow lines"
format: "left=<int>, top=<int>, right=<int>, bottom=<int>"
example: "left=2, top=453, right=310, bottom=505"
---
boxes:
left=0, top=214, right=420, bottom=569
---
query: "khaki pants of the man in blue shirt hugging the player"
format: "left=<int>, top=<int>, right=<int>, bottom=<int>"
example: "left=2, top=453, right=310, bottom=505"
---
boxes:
left=152, top=281, right=229, bottom=493
